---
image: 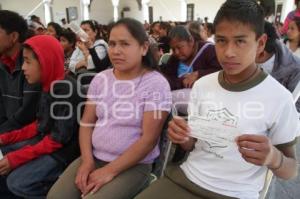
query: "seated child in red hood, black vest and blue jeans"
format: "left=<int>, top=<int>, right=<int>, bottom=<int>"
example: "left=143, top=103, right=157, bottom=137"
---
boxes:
left=0, top=35, right=82, bottom=198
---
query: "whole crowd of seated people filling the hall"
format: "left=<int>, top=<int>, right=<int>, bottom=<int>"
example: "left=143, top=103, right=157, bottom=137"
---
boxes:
left=0, top=0, right=300, bottom=199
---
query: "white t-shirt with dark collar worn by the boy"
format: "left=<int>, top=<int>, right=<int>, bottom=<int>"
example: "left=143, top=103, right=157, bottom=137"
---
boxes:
left=181, top=71, right=300, bottom=199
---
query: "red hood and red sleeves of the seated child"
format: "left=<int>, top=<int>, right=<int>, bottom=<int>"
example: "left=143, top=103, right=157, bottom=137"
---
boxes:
left=0, top=35, right=64, bottom=169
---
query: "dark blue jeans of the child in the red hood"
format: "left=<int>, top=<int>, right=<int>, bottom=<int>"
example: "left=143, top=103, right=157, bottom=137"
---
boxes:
left=0, top=139, right=64, bottom=199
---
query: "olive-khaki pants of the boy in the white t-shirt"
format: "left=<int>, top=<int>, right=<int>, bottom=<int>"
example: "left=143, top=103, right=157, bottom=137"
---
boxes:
left=135, top=166, right=237, bottom=199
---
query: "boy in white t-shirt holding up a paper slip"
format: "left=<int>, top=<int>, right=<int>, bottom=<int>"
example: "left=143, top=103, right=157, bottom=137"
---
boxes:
left=137, top=0, right=300, bottom=199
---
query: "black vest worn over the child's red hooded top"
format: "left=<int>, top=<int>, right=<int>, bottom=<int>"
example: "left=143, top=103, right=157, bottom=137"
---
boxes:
left=37, top=76, right=84, bottom=166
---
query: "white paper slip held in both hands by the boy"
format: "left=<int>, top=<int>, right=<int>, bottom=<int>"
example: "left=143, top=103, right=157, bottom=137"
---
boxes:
left=188, top=116, right=240, bottom=145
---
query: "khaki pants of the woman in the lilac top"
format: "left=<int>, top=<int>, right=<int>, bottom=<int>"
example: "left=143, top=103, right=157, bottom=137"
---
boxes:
left=47, top=158, right=151, bottom=199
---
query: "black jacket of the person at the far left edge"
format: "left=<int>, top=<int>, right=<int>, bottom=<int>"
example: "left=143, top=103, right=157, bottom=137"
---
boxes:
left=0, top=53, right=41, bottom=133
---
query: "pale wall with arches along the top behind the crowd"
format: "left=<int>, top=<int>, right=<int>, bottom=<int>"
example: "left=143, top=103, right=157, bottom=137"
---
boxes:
left=0, top=0, right=294, bottom=24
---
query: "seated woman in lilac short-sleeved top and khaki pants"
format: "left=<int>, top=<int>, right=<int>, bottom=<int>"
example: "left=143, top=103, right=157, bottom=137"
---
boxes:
left=47, top=18, right=171, bottom=199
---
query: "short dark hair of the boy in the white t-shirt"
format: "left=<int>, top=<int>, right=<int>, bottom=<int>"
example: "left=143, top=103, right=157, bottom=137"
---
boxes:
left=214, top=0, right=264, bottom=38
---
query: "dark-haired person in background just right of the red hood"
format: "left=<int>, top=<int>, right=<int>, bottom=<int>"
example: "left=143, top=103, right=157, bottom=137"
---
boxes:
left=59, top=29, right=76, bottom=73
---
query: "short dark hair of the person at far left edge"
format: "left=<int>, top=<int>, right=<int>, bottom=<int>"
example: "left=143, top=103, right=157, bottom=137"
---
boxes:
left=0, top=10, right=28, bottom=43
